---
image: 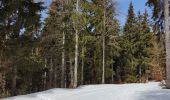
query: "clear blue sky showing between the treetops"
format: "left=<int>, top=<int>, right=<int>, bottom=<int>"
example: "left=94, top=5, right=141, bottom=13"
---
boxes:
left=42, top=0, right=150, bottom=26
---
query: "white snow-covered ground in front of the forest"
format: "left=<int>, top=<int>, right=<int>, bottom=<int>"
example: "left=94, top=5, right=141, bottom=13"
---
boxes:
left=4, top=82, right=170, bottom=100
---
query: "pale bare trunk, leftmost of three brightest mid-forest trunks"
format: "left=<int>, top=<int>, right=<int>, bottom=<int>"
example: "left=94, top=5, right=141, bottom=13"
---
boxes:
left=61, top=28, right=65, bottom=88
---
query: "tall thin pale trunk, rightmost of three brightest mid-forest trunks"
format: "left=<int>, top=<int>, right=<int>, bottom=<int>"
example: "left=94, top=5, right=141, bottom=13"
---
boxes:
left=102, top=0, right=106, bottom=84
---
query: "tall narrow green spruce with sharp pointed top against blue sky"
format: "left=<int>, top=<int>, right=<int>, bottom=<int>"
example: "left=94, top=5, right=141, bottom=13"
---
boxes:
left=123, top=2, right=137, bottom=81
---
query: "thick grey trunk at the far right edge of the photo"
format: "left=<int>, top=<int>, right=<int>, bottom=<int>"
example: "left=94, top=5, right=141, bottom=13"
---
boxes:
left=164, top=0, right=170, bottom=88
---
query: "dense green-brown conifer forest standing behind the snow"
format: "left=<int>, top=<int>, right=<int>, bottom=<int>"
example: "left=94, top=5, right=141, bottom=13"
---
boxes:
left=0, top=0, right=165, bottom=97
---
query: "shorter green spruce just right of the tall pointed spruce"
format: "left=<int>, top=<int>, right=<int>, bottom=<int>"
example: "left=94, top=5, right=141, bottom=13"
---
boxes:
left=135, top=10, right=153, bottom=82
